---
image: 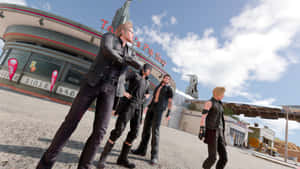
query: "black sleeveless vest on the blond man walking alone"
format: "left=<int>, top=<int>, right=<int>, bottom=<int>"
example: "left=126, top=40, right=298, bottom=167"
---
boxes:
left=205, top=98, right=225, bottom=130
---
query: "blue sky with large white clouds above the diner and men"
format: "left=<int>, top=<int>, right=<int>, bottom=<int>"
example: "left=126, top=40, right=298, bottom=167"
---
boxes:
left=0, top=0, right=300, bottom=145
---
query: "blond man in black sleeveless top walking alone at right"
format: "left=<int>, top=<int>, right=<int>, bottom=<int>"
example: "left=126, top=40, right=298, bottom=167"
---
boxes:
left=199, top=87, right=228, bottom=169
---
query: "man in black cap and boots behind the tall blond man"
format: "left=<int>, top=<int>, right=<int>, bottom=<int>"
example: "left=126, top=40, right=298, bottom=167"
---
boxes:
left=97, top=63, right=152, bottom=169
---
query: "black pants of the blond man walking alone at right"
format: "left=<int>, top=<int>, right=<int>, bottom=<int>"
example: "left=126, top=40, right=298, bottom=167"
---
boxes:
left=202, top=129, right=228, bottom=169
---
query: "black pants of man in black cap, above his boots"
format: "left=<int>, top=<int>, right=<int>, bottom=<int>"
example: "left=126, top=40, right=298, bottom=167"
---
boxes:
left=109, top=104, right=141, bottom=144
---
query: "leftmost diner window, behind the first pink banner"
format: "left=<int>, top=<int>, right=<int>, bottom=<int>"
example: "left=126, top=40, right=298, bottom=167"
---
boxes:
left=4, top=49, right=30, bottom=70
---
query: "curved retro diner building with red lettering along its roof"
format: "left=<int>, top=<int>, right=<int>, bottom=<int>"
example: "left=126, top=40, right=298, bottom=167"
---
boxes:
left=0, top=1, right=176, bottom=102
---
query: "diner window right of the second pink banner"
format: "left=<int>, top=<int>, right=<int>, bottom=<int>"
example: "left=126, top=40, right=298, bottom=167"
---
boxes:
left=64, top=65, right=88, bottom=86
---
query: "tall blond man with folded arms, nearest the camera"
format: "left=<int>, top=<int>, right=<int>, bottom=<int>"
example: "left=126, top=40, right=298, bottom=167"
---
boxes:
left=37, top=22, right=140, bottom=169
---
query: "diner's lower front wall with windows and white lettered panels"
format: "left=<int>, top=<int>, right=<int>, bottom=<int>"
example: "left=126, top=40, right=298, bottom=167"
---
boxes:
left=0, top=42, right=91, bottom=101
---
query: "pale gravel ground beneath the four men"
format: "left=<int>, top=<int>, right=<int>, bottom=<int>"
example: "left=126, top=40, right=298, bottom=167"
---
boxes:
left=0, top=89, right=287, bottom=169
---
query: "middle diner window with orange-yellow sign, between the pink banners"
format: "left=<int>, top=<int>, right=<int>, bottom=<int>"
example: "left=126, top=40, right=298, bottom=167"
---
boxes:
left=25, top=53, right=64, bottom=79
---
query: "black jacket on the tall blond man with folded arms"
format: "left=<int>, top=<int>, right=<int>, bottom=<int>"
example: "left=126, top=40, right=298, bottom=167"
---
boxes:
left=86, top=33, right=141, bottom=86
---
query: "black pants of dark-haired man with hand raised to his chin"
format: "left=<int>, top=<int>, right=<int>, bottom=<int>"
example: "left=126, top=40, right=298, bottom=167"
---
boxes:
left=138, top=105, right=163, bottom=159
